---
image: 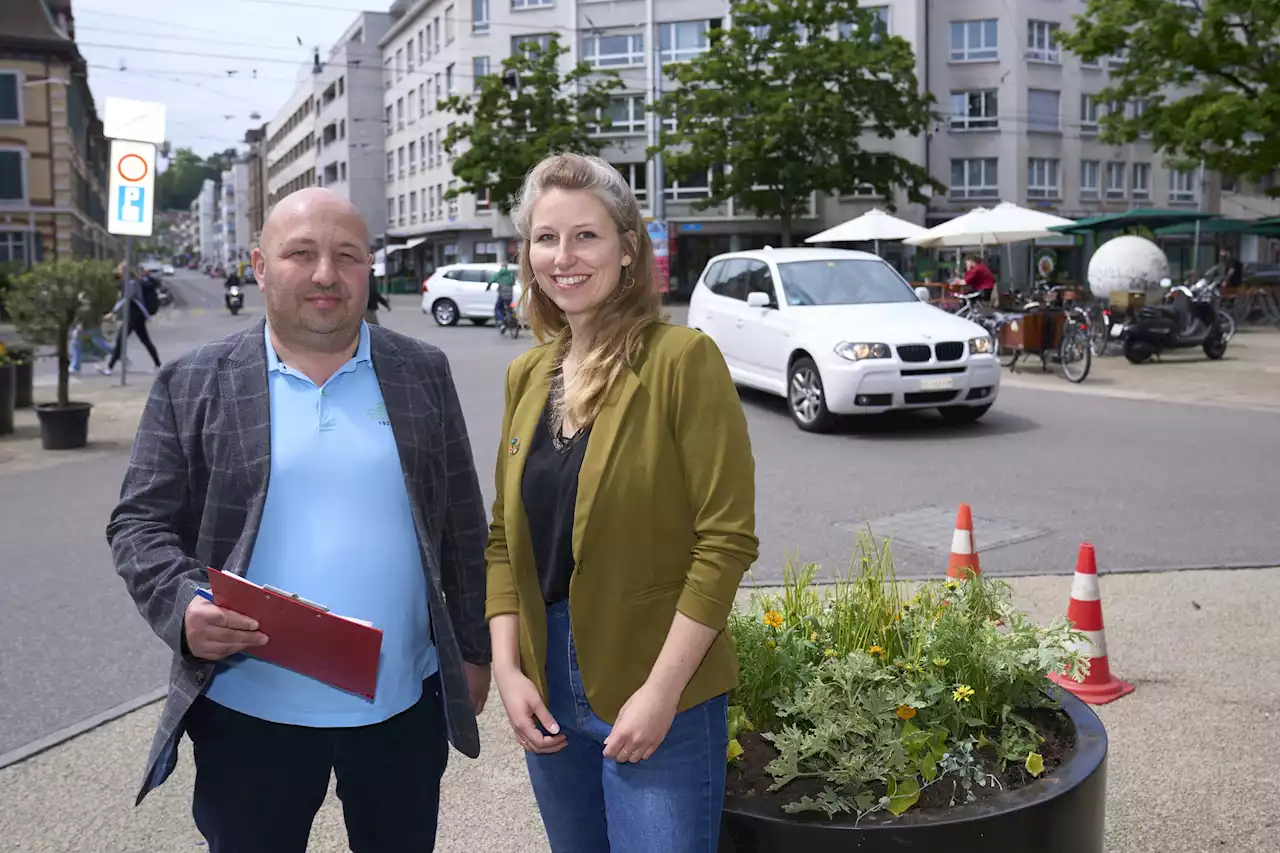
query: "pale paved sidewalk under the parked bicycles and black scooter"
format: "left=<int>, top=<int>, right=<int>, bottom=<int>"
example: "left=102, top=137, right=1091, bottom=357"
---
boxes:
left=1002, top=328, right=1280, bottom=411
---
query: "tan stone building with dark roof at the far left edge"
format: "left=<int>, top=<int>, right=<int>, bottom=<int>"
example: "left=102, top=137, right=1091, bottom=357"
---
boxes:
left=0, top=0, right=119, bottom=265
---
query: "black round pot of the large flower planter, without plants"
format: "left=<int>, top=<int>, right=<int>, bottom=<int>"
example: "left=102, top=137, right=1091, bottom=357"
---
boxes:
left=719, top=688, right=1107, bottom=853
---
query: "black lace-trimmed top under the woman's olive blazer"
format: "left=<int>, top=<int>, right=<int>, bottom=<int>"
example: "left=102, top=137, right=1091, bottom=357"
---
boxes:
left=520, top=373, right=591, bottom=605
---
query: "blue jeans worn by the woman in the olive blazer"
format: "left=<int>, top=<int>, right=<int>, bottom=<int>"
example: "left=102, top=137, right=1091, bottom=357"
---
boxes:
left=526, top=602, right=728, bottom=853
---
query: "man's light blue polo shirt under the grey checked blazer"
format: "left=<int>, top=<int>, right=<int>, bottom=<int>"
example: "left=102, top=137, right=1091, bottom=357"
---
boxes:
left=206, top=318, right=438, bottom=727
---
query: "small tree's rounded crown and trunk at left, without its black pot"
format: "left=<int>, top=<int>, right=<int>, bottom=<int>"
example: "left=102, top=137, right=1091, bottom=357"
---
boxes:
left=9, top=259, right=116, bottom=406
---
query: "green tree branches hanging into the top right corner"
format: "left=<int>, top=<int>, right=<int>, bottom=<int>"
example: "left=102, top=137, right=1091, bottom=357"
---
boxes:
left=1060, top=0, right=1280, bottom=192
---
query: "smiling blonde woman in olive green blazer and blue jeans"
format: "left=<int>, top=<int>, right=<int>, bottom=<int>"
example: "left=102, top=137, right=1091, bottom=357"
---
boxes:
left=486, top=154, right=759, bottom=853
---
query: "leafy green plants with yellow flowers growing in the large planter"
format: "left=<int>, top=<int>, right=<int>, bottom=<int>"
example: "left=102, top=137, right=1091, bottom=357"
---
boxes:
left=730, top=535, right=1088, bottom=817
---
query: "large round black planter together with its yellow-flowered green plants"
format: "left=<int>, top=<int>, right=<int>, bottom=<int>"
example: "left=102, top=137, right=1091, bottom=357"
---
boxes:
left=721, top=535, right=1107, bottom=853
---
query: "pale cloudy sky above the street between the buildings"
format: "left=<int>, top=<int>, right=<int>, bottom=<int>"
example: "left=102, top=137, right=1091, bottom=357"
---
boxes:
left=73, top=0, right=376, bottom=156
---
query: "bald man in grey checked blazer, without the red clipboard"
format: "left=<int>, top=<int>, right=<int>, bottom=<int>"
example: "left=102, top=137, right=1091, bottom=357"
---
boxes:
left=106, top=190, right=490, bottom=853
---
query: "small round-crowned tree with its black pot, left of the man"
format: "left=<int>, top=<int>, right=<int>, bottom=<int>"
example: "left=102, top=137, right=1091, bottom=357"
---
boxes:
left=8, top=259, right=116, bottom=450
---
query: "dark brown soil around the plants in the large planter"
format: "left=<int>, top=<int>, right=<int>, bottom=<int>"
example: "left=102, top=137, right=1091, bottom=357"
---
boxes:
left=726, top=708, right=1075, bottom=822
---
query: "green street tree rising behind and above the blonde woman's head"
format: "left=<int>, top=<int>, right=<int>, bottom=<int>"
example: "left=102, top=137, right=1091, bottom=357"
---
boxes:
left=439, top=40, right=622, bottom=215
